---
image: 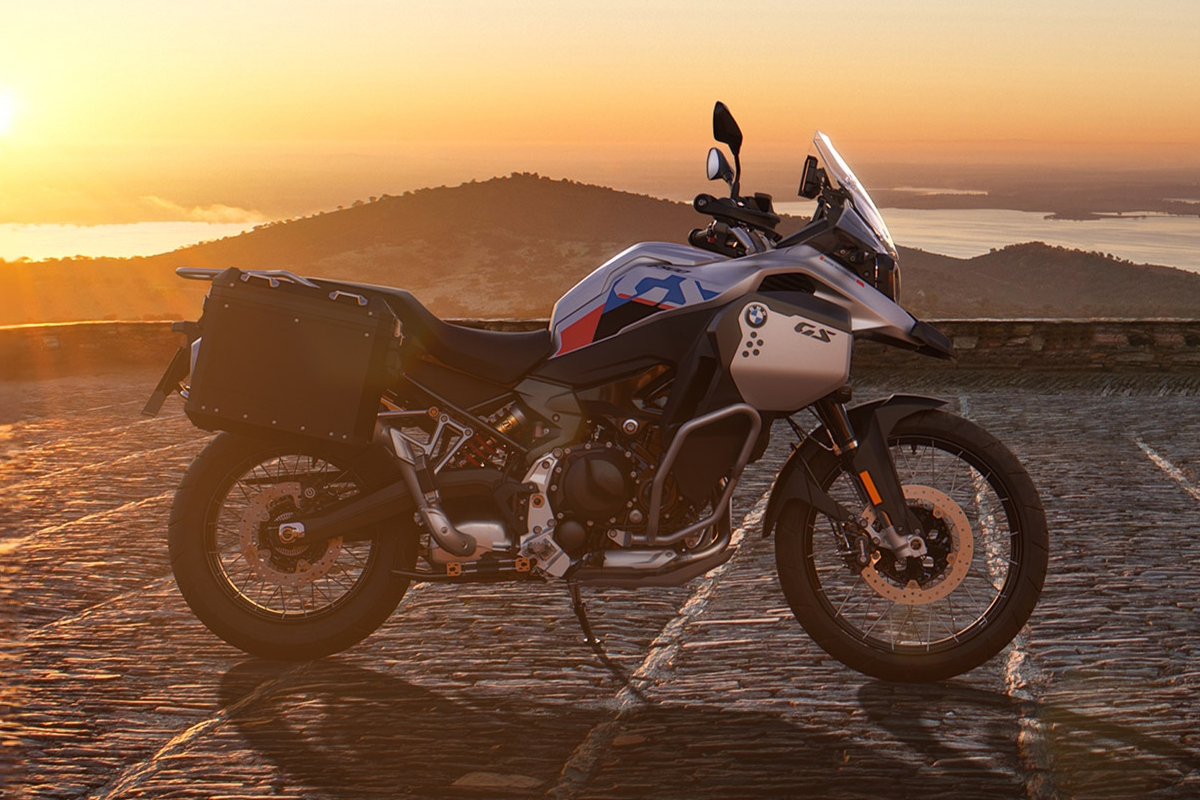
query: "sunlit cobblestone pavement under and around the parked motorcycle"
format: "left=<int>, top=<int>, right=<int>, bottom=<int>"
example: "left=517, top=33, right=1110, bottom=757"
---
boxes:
left=0, top=373, right=1200, bottom=799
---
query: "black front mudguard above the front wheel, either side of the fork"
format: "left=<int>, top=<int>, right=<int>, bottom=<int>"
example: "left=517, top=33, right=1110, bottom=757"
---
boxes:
left=762, top=395, right=946, bottom=536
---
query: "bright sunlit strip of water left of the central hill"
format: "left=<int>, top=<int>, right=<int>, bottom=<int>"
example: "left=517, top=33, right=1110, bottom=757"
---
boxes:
left=0, top=222, right=256, bottom=261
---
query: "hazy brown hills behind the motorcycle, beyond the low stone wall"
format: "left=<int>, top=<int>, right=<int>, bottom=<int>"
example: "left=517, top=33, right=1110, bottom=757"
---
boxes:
left=0, top=174, right=1200, bottom=325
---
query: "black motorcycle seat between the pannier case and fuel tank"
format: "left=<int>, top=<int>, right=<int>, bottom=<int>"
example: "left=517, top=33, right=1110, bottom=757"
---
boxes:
left=344, top=283, right=553, bottom=386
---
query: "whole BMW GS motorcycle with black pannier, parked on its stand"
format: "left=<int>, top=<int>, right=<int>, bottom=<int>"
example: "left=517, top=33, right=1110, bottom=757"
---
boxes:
left=146, top=103, right=1049, bottom=681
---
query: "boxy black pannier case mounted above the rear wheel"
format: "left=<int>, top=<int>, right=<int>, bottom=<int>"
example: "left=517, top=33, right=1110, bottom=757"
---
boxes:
left=184, top=269, right=400, bottom=445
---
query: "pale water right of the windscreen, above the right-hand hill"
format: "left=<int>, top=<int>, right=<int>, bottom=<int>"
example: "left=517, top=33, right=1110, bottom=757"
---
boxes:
left=776, top=203, right=1200, bottom=272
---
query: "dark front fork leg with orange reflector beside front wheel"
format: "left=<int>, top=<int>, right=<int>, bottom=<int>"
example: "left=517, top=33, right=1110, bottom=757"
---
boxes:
left=814, top=396, right=928, bottom=560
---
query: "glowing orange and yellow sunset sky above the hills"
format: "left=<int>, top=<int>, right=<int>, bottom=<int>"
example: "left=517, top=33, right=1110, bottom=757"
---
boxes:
left=0, top=0, right=1200, bottom=223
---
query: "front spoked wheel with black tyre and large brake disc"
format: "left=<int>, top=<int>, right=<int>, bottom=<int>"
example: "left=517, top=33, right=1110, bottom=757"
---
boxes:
left=775, top=410, right=1049, bottom=681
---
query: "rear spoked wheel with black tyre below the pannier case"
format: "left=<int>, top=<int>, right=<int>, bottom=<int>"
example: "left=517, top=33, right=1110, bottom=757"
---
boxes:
left=169, top=434, right=415, bottom=660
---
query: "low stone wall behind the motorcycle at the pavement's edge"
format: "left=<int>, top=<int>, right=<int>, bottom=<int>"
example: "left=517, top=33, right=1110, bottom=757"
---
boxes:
left=0, top=319, right=1200, bottom=380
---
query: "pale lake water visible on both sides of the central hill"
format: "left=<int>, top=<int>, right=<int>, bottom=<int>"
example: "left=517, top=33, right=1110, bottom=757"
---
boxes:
left=0, top=209, right=1200, bottom=272
